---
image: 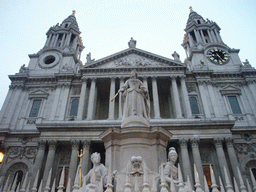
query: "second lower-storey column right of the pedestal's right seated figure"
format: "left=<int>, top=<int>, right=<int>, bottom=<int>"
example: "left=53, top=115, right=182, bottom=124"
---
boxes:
left=190, top=138, right=204, bottom=186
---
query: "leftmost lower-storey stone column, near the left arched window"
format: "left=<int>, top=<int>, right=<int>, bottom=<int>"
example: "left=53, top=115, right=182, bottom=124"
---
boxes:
left=30, top=141, right=46, bottom=187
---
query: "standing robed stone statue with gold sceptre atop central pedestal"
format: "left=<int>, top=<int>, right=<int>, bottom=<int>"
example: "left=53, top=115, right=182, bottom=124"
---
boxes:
left=119, top=70, right=150, bottom=128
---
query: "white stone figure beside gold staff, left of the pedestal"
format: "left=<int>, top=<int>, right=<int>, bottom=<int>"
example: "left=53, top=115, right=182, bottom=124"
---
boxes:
left=83, top=152, right=108, bottom=192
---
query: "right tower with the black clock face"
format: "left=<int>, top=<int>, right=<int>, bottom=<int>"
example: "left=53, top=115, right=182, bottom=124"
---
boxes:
left=182, top=7, right=242, bottom=72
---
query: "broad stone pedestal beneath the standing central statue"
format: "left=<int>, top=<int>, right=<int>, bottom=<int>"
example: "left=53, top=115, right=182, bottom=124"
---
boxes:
left=100, top=127, right=171, bottom=172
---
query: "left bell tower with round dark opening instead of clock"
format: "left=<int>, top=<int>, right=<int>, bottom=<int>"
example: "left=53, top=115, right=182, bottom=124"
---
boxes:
left=28, top=11, right=84, bottom=76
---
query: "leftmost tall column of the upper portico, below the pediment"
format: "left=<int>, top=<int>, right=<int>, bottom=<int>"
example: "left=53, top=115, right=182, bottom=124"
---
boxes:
left=77, top=78, right=87, bottom=120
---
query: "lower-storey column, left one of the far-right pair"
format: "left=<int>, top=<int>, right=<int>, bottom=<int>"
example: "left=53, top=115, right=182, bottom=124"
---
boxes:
left=214, top=138, right=232, bottom=181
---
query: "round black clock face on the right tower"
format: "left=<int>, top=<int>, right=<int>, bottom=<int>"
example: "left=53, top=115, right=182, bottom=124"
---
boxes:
left=206, top=47, right=230, bottom=65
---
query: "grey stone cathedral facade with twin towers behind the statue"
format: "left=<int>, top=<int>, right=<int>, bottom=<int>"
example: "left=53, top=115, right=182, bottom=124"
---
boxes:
left=0, top=10, right=256, bottom=190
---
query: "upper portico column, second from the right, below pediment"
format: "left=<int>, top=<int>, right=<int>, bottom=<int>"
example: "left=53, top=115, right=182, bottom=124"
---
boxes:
left=171, top=76, right=182, bottom=119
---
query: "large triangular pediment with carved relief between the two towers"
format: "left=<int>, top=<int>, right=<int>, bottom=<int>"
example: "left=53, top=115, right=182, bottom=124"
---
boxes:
left=84, top=48, right=186, bottom=68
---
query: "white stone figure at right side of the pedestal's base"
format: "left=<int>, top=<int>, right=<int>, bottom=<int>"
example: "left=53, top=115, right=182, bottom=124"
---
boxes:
left=163, top=147, right=178, bottom=185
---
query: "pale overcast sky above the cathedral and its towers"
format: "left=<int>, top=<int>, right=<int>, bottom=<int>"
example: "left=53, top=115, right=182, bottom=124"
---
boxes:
left=0, top=0, right=256, bottom=107
